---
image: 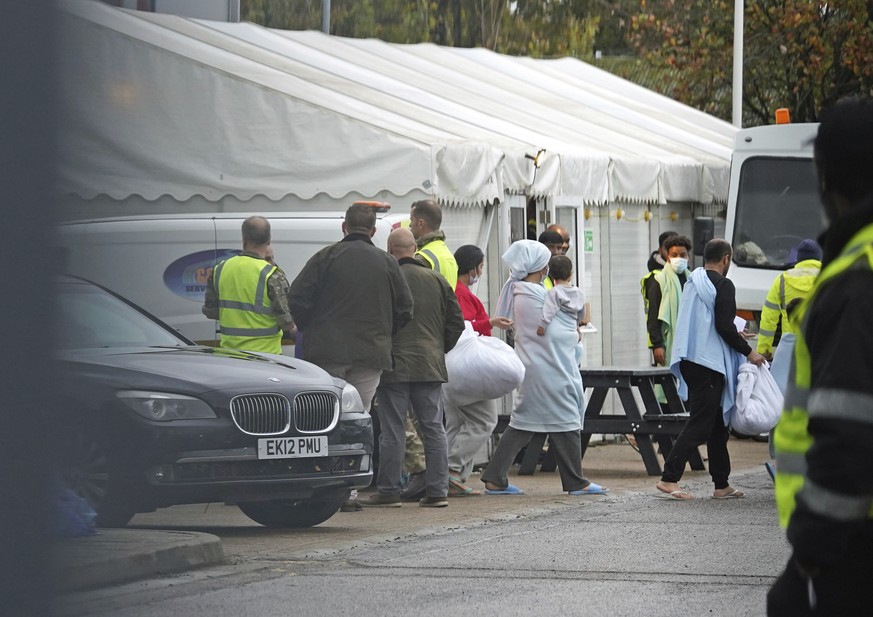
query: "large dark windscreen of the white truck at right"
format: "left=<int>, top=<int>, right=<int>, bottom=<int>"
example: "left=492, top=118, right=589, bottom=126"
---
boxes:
left=733, top=157, right=824, bottom=270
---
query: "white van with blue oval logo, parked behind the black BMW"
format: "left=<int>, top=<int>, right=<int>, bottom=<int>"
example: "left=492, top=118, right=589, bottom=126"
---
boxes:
left=58, top=208, right=409, bottom=348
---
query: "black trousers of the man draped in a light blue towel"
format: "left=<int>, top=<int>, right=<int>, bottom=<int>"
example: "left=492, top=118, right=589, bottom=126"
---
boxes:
left=661, top=360, right=731, bottom=489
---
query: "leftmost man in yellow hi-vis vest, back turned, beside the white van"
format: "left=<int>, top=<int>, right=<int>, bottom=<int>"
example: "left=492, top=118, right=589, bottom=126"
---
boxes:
left=202, top=216, right=294, bottom=354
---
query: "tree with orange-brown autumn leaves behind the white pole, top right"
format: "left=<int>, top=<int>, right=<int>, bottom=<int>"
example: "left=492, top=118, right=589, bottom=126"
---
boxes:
left=631, top=0, right=873, bottom=126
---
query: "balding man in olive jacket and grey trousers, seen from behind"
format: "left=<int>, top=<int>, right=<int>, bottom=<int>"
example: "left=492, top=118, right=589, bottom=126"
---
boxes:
left=364, top=228, right=464, bottom=508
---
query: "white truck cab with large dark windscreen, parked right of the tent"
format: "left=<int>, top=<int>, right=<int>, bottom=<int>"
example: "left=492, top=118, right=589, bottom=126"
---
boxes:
left=725, top=124, right=825, bottom=321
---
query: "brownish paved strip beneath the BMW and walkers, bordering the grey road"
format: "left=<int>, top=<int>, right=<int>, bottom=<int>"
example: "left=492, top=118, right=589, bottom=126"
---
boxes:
left=54, top=438, right=775, bottom=591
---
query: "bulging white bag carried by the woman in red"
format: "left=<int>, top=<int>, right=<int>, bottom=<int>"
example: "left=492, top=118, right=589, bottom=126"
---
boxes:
left=443, top=321, right=524, bottom=405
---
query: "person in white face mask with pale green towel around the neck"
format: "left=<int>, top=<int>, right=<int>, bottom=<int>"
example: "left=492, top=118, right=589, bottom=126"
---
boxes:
left=646, top=236, right=691, bottom=366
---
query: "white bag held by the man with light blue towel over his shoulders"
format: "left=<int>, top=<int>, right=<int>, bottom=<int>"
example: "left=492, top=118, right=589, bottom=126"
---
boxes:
left=731, top=362, right=784, bottom=435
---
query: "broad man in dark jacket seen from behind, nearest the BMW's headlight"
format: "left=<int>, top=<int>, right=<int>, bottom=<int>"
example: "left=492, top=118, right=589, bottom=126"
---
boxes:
left=289, top=204, right=412, bottom=509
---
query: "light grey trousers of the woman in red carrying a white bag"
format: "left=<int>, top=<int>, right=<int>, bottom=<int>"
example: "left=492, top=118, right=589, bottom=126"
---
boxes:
left=443, top=389, right=497, bottom=482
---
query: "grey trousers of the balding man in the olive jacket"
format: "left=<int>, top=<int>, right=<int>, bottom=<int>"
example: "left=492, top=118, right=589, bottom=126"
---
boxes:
left=376, top=381, right=449, bottom=497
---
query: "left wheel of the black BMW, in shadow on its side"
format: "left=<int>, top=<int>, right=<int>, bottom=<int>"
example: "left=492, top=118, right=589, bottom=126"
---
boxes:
left=61, top=430, right=135, bottom=527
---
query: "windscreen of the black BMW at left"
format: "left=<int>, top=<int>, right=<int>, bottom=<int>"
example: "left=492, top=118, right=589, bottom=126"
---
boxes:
left=56, top=282, right=187, bottom=349
